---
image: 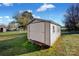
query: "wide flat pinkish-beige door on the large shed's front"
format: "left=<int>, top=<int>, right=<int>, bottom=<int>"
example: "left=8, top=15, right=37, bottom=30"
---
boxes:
left=29, top=22, right=45, bottom=43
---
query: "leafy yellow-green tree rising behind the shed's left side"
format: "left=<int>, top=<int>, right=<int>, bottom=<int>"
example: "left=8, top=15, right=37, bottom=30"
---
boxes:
left=13, top=11, right=33, bottom=30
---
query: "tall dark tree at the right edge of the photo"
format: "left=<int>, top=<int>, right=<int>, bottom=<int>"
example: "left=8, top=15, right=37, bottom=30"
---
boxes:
left=64, top=4, right=79, bottom=31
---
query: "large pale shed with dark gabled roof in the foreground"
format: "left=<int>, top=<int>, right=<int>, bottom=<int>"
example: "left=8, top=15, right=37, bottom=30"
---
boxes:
left=27, top=18, right=61, bottom=46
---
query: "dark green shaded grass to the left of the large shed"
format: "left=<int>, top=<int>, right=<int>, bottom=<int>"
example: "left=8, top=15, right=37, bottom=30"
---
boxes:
left=0, top=34, right=41, bottom=56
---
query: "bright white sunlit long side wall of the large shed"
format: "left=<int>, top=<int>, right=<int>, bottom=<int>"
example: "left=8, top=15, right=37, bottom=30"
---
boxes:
left=50, top=24, right=60, bottom=46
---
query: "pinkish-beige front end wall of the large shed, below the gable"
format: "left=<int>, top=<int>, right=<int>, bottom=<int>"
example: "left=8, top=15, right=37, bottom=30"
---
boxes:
left=29, top=22, right=49, bottom=45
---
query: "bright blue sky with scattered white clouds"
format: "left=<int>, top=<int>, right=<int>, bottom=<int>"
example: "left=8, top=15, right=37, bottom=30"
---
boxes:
left=0, top=3, right=71, bottom=25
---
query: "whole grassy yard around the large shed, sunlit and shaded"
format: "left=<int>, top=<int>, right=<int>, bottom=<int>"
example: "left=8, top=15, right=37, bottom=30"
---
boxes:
left=0, top=32, right=79, bottom=56
